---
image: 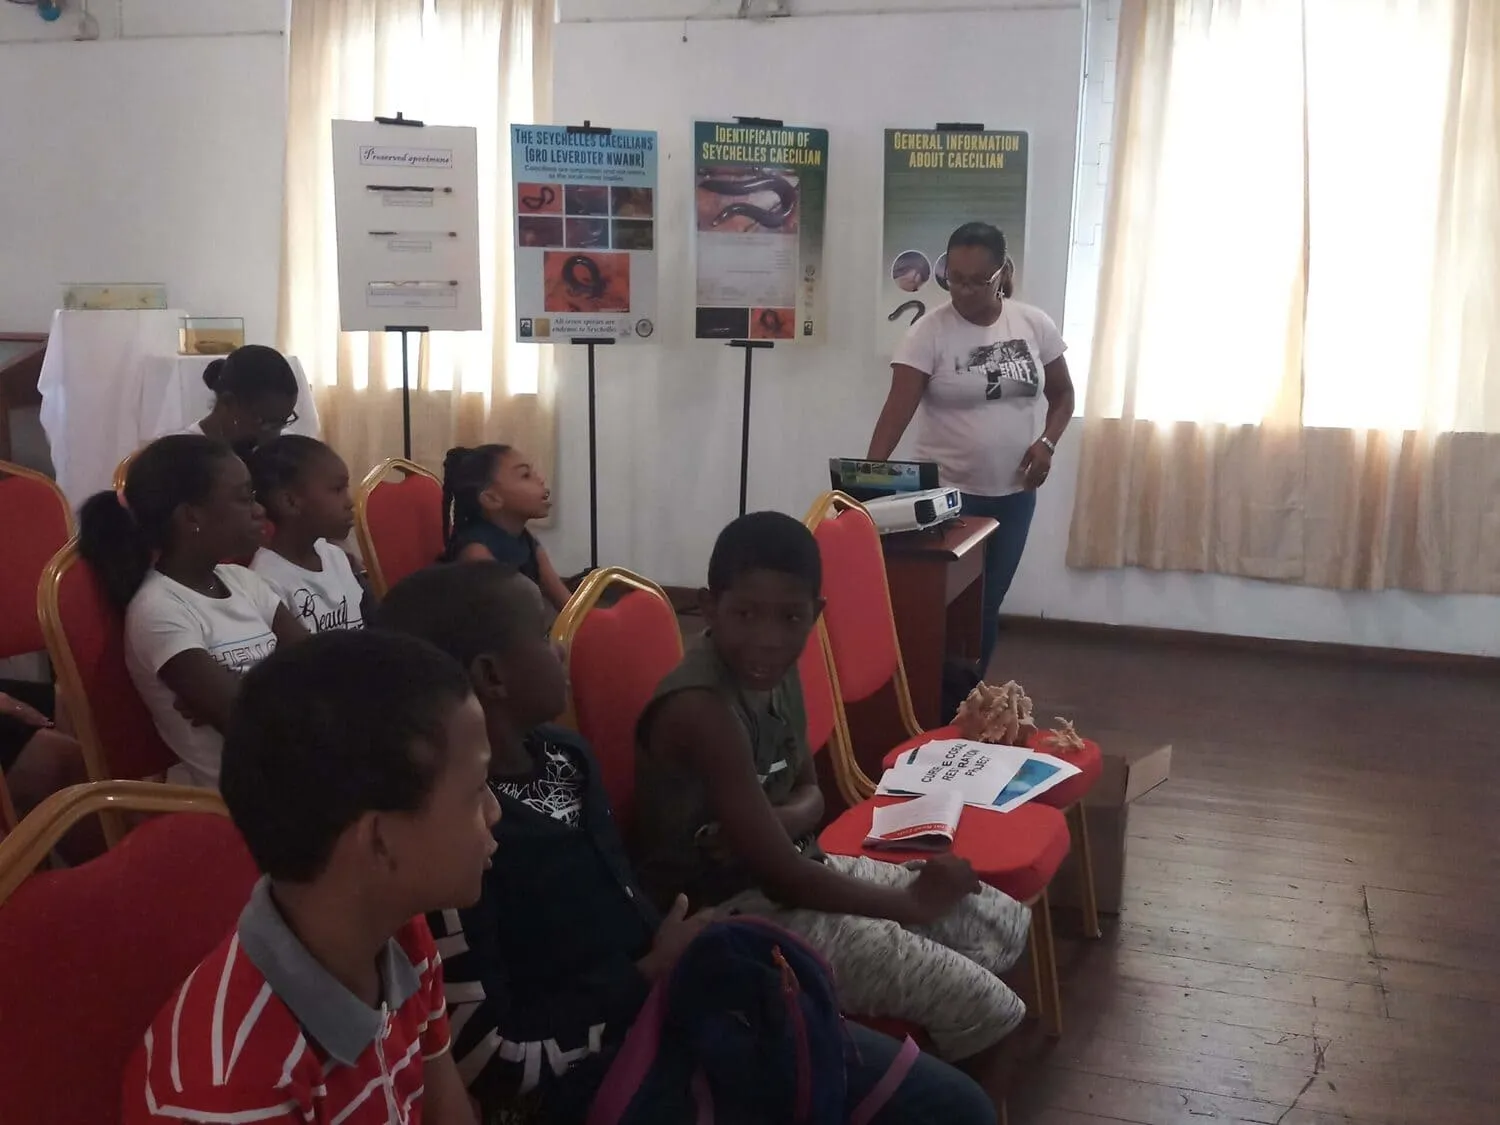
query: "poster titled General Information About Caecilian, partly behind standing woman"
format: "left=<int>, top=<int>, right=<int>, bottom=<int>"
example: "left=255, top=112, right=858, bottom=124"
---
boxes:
left=876, top=129, right=1029, bottom=356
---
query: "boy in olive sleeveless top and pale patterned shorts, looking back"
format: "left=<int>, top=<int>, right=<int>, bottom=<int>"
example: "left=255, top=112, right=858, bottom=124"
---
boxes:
left=635, top=512, right=1031, bottom=1059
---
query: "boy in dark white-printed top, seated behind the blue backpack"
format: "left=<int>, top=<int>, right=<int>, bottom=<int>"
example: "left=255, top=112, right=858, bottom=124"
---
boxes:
left=377, top=563, right=995, bottom=1125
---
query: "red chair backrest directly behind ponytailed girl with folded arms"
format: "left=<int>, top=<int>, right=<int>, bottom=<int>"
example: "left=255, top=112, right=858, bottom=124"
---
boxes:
left=42, top=545, right=177, bottom=782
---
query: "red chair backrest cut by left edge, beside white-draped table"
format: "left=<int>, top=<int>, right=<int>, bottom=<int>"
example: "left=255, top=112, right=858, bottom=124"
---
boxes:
left=0, top=462, right=72, bottom=660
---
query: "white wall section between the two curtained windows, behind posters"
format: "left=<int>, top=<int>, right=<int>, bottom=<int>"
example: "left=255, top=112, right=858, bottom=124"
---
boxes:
left=554, top=0, right=1083, bottom=573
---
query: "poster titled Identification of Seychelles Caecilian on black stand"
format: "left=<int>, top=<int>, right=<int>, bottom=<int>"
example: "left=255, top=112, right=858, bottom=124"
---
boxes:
left=693, top=122, right=828, bottom=342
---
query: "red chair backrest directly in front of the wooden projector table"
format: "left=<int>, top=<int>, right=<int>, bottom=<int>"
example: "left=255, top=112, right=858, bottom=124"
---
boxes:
left=813, top=509, right=900, bottom=704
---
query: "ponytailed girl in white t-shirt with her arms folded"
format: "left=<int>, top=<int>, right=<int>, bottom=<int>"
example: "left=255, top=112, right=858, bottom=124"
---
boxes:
left=78, top=434, right=308, bottom=788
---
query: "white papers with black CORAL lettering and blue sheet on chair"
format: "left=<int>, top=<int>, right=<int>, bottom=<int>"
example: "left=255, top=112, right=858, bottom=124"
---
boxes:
left=878, top=738, right=1079, bottom=813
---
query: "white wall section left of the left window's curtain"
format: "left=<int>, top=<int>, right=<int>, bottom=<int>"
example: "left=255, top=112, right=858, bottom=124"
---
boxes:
left=0, top=0, right=287, bottom=342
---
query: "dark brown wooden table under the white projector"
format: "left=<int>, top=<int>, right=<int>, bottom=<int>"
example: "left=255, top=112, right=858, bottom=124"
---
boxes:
left=881, top=516, right=998, bottom=728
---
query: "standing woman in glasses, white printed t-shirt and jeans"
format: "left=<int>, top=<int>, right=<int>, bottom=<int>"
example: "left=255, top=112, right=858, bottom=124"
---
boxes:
left=869, top=222, right=1073, bottom=675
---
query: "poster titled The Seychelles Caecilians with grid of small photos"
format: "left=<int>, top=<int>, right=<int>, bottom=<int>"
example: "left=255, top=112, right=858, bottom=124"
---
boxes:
left=510, top=125, right=657, bottom=344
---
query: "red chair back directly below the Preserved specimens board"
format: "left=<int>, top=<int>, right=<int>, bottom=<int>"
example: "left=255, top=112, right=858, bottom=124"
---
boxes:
left=354, top=458, right=446, bottom=597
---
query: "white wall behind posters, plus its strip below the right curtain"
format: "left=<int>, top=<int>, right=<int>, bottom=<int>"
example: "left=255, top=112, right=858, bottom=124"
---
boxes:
left=545, top=0, right=1500, bottom=656
